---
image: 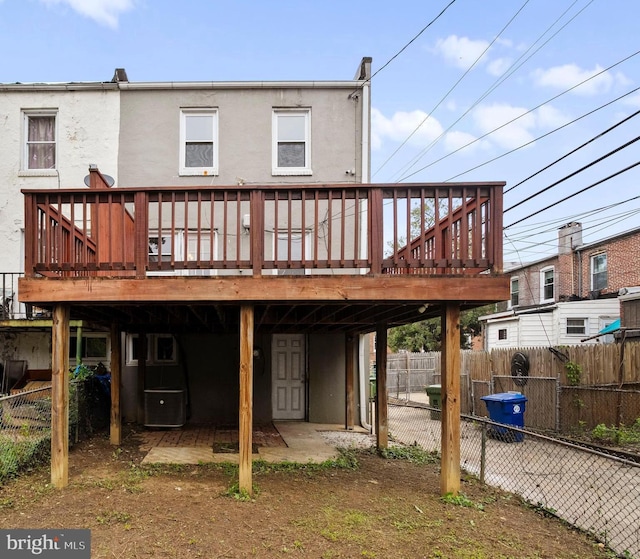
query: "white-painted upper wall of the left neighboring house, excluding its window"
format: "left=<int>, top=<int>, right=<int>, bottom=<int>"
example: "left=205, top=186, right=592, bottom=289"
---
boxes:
left=0, top=86, right=120, bottom=272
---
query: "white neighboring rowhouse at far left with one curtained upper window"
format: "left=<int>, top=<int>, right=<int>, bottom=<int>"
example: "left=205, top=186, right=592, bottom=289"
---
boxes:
left=0, top=77, right=120, bottom=369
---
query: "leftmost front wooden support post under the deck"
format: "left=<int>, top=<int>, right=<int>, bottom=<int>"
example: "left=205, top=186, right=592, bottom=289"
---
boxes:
left=51, top=304, right=69, bottom=488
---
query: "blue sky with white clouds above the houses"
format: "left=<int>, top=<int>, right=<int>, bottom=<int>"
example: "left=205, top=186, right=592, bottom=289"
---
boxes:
left=0, top=0, right=640, bottom=263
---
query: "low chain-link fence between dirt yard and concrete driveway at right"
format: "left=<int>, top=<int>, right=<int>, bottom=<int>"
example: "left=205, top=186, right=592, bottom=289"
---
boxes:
left=389, top=401, right=640, bottom=558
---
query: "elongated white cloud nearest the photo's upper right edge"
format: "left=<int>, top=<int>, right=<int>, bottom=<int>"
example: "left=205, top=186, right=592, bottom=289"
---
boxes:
left=532, top=64, right=629, bottom=95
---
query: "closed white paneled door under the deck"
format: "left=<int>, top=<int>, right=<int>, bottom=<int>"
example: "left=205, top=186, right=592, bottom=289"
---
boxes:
left=271, top=334, right=306, bottom=420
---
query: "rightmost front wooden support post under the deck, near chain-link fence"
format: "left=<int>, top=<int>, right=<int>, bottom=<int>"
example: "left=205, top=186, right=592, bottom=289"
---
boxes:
left=440, top=302, right=460, bottom=495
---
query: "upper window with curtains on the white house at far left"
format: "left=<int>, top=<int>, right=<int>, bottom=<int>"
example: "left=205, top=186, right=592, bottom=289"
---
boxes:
left=22, top=110, right=57, bottom=171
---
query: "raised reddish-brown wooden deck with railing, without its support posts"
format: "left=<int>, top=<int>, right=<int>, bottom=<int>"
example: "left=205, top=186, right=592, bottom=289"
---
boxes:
left=20, top=169, right=508, bottom=332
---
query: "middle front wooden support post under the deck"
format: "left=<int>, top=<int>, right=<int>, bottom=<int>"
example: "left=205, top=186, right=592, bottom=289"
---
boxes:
left=238, top=305, right=254, bottom=495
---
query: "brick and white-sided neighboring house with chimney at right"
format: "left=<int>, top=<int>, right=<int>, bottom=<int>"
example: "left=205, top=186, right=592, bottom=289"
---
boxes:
left=481, top=222, right=640, bottom=349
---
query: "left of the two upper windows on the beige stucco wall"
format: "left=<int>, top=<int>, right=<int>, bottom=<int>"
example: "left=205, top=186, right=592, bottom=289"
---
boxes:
left=180, top=109, right=218, bottom=175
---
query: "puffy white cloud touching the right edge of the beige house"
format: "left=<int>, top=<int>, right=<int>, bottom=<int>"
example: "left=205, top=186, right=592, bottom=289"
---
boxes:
left=371, top=108, right=442, bottom=149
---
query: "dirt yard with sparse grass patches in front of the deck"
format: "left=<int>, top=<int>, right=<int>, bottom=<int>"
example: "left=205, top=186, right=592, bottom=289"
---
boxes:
left=0, top=434, right=613, bottom=559
